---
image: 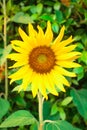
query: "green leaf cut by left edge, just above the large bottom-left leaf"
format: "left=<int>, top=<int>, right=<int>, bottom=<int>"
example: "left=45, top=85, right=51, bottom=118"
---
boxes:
left=0, top=98, right=10, bottom=119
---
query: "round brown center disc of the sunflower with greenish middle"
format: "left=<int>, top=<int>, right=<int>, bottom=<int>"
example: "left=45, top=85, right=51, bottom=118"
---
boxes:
left=29, top=46, right=56, bottom=74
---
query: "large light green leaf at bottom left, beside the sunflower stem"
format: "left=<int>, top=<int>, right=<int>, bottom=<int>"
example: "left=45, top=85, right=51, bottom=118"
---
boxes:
left=0, top=110, right=36, bottom=128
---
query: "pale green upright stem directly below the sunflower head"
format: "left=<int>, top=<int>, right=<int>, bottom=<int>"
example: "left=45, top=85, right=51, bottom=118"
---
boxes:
left=38, top=92, right=44, bottom=130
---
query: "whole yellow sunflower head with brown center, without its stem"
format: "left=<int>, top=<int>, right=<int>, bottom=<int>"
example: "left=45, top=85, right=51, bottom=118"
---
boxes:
left=8, top=21, right=80, bottom=98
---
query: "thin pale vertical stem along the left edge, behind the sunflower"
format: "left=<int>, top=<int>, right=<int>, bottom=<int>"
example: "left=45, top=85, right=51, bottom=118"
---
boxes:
left=3, top=0, right=8, bottom=99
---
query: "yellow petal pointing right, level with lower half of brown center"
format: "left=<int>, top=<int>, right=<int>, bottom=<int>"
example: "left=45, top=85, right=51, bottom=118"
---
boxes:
left=56, top=61, right=81, bottom=68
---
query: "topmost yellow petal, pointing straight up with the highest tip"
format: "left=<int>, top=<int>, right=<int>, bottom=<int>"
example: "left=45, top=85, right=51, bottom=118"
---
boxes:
left=45, top=21, right=53, bottom=45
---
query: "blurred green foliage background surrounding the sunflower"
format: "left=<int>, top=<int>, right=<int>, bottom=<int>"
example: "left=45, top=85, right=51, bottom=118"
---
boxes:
left=0, top=0, right=87, bottom=130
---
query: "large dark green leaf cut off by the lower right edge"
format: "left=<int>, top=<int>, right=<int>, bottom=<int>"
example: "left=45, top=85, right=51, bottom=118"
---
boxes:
left=71, top=89, right=87, bottom=120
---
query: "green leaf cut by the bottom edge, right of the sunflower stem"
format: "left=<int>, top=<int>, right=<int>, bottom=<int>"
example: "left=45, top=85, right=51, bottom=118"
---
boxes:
left=44, top=120, right=81, bottom=130
